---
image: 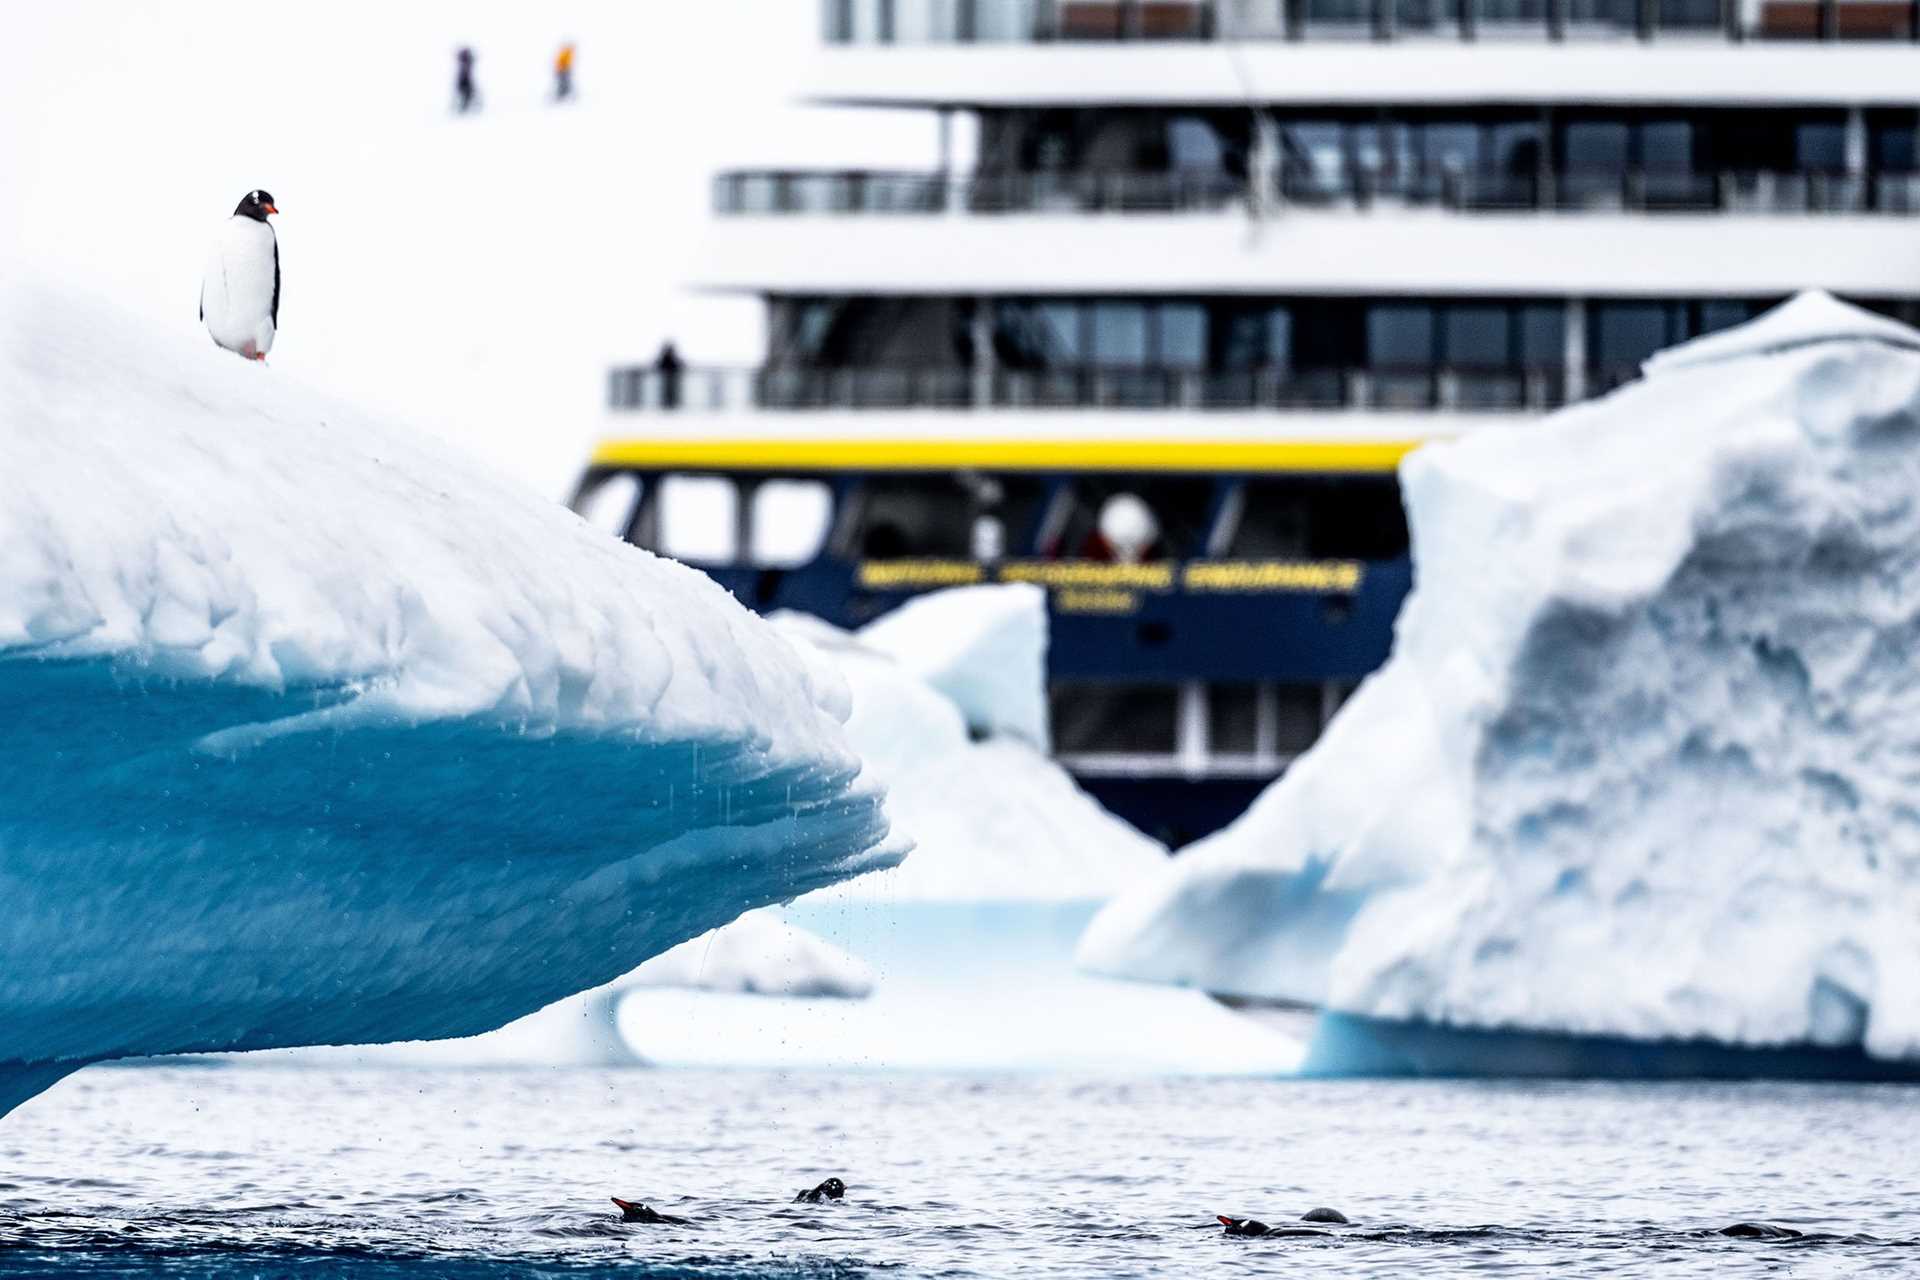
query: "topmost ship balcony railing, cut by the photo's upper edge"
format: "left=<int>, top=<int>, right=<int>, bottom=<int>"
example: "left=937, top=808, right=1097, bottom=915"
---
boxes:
left=824, top=0, right=1920, bottom=44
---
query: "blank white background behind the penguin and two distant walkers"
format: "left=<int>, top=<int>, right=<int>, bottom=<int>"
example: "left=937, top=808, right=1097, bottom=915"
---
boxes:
left=0, top=0, right=935, bottom=497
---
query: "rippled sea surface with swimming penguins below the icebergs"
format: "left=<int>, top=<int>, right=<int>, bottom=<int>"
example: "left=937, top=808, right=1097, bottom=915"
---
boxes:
left=0, top=1067, right=1920, bottom=1276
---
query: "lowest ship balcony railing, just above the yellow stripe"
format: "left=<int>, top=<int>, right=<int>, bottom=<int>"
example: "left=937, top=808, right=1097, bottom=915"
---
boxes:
left=607, top=365, right=1605, bottom=413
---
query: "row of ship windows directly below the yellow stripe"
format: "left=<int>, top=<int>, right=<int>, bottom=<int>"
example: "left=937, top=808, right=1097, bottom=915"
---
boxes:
left=576, top=472, right=1407, bottom=568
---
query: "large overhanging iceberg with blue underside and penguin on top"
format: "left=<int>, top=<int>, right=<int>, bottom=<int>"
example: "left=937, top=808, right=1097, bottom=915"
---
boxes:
left=0, top=285, right=900, bottom=1113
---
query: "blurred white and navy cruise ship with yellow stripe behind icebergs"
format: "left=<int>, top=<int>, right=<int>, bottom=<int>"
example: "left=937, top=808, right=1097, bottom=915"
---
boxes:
left=574, top=0, right=1920, bottom=846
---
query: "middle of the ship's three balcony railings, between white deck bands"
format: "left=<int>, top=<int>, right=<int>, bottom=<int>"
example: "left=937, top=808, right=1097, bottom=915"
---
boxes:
left=714, top=165, right=1920, bottom=215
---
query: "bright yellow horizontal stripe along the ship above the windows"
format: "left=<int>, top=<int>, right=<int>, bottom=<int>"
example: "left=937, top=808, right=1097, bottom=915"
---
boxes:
left=593, top=439, right=1425, bottom=474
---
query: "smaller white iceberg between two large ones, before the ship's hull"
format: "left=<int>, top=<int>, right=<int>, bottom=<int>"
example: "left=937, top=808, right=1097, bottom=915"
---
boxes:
left=616, top=585, right=1302, bottom=1075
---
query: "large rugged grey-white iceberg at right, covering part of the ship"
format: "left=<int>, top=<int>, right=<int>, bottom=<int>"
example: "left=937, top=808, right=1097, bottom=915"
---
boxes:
left=1081, top=294, right=1920, bottom=1075
